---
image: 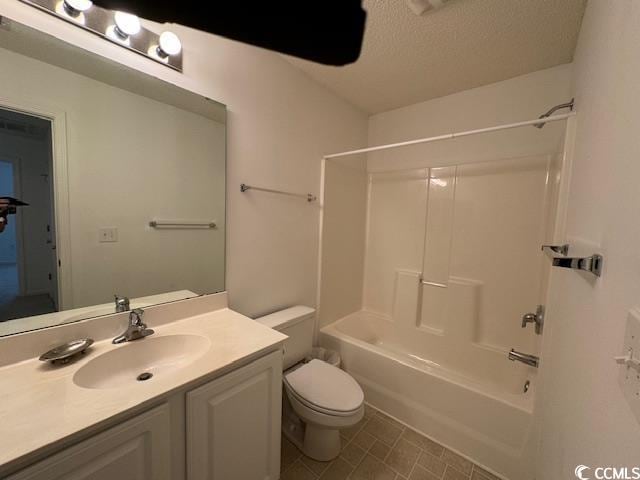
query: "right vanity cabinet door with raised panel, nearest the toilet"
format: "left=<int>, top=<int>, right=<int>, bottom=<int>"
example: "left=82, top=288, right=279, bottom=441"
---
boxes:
left=187, top=351, right=282, bottom=480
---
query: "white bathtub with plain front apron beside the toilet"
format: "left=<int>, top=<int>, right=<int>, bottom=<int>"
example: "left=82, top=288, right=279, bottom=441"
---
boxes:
left=319, top=311, right=535, bottom=480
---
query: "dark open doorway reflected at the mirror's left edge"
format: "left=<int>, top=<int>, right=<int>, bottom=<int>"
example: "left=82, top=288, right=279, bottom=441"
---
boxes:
left=0, top=109, right=58, bottom=322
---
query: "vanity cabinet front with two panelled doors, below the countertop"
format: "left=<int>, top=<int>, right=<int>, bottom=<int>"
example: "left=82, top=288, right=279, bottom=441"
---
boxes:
left=5, top=350, right=282, bottom=480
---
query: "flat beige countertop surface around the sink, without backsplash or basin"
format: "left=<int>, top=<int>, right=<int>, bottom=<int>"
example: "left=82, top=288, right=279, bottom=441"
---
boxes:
left=0, top=308, right=286, bottom=471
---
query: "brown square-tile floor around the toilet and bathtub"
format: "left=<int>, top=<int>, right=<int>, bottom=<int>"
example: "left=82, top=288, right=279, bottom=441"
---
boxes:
left=280, top=405, right=499, bottom=480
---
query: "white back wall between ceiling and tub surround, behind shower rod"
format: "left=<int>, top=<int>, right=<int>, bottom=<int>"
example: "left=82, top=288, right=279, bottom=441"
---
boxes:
left=369, top=65, right=572, bottom=166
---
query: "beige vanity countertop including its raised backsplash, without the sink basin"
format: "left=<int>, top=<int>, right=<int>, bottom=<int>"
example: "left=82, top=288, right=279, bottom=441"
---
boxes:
left=0, top=294, right=286, bottom=477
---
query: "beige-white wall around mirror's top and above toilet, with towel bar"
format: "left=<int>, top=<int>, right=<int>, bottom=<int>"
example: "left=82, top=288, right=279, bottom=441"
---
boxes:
left=0, top=0, right=367, bottom=315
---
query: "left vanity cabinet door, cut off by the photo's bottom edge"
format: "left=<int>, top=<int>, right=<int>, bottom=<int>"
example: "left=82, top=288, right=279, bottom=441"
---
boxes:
left=7, top=404, right=171, bottom=480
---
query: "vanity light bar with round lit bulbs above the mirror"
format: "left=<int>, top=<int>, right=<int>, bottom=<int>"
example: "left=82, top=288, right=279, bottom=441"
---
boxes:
left=20, top=0, right=183, bottom=72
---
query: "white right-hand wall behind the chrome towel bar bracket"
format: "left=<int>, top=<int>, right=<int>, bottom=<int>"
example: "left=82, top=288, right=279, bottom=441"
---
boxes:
left=537, top=0, right=640, bottom=480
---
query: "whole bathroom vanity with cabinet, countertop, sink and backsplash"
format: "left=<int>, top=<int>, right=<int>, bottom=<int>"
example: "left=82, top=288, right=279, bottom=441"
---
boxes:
left=0, top=293, right=286, bottom=480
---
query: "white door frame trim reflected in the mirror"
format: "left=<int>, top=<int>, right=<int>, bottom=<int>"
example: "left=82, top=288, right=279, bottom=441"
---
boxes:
left=0, top=94, right=73, bottom=311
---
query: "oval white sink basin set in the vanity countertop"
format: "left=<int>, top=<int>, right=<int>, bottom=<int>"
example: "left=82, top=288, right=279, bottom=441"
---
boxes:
left=73, top=335, right=211, bottom=389
